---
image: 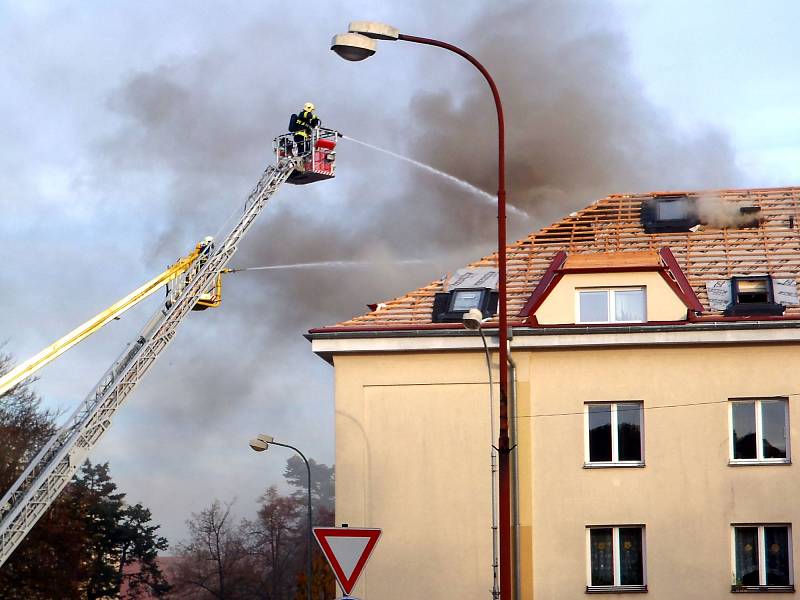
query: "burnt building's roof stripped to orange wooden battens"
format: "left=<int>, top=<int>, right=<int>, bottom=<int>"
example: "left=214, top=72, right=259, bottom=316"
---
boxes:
left=324, top=187, right=800, bottom=329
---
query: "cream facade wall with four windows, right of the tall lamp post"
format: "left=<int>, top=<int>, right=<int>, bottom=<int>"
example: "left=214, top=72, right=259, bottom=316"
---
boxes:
left=520, top=346, right=800, bottom=600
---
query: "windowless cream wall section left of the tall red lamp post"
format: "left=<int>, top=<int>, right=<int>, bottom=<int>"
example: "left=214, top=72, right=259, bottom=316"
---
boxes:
left=335, top=353, right=492, bottom=600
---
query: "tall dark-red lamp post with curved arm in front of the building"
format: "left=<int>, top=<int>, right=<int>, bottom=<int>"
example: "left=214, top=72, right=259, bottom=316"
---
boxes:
left=331, top=21, right=512, bottom=600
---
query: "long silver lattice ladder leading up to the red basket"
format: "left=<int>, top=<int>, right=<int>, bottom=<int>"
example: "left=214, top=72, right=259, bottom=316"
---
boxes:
left=0, top=158, right=295, bottom=566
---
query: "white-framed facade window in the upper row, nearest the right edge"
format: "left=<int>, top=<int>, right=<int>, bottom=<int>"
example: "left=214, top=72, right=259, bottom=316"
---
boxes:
left=730, top=398, right=790, bottom=464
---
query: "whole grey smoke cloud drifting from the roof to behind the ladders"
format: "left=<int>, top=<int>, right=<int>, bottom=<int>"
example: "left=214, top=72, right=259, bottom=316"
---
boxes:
left=83, top=0, right=739, bottom=544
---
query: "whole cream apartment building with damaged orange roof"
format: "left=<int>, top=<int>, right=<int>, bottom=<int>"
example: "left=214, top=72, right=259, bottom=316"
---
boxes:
left=309, top=188, right=800, bottom=600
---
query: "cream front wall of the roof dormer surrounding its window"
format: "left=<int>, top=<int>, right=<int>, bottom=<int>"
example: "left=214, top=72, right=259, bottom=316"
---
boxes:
left=536, top=271, right=686, bottom=325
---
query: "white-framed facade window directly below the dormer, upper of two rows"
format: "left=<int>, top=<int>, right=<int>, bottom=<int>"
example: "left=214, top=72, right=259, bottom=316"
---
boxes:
left=585, top=402, right=644, bottom=467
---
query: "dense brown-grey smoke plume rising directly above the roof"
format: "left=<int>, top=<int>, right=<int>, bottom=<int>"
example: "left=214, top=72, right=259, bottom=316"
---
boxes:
left=413, top=0, right=740, bottom=233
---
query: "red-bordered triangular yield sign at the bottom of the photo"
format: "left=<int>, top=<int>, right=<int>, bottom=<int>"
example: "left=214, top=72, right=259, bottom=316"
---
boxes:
left=314, top=527, right=381, bottom=595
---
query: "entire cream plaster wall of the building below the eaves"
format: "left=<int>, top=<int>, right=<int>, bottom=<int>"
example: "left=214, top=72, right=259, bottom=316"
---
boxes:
left=335, top=344, right=800, bottom=600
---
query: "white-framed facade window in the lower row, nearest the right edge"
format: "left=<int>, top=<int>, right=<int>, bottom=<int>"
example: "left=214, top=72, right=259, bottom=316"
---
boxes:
left=732, top=525, right=794, bottom=591
